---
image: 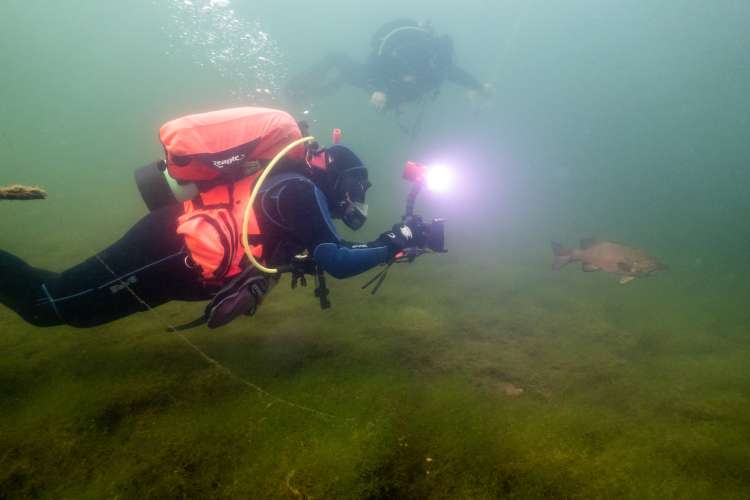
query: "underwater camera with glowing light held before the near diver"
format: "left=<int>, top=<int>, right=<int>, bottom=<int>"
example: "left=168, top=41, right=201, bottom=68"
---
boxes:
left=402, top=161, right=452, bottom=253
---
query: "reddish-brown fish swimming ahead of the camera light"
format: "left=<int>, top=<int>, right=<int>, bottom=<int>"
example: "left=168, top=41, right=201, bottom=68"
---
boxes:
left=552, top=239, right=666, bottom=285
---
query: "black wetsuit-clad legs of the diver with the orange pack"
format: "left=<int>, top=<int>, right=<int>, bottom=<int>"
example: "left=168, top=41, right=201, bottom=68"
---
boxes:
left=0, top=206, right=208, bottom=327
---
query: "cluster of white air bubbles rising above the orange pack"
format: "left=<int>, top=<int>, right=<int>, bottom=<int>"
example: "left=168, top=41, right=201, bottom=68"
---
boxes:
left=163, top=0, right=286, bottom=104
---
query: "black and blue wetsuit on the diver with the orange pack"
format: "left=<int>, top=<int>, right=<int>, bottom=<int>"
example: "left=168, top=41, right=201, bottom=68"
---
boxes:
left=0, top=173, right=393, bottom=327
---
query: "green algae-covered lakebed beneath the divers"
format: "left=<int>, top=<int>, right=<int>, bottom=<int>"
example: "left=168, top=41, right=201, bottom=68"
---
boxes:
left=0, top=255, right=750, bottom=499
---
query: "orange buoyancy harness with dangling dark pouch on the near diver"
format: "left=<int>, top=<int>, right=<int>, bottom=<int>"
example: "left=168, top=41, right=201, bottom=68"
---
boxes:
left=159, top=107, right=330, bottom=329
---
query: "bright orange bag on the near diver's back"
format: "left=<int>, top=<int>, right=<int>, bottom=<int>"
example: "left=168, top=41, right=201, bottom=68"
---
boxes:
left=159, top=107, right=305, bottom=283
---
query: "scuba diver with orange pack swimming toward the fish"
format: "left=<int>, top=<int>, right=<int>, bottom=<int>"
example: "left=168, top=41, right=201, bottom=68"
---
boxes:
left=0, top=107, right=434, bottom=327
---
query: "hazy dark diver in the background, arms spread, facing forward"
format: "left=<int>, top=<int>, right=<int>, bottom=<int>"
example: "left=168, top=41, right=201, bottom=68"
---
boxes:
left=286, top=19, right=491, bottom=132
